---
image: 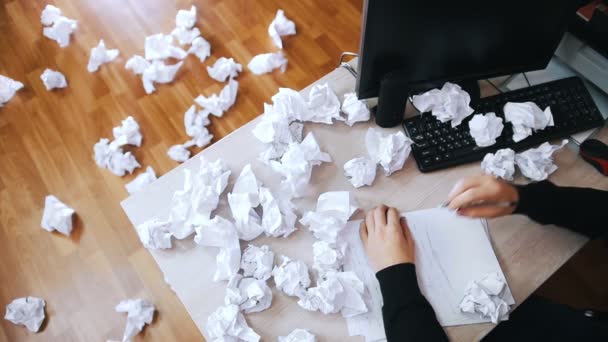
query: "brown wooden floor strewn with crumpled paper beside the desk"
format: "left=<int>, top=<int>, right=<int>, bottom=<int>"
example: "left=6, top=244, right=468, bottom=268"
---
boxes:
left=0, top=0, right=608, bottom=342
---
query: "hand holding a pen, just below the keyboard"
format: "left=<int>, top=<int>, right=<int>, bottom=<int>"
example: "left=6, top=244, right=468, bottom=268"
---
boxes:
left=448, top=175, right=519, bottom=218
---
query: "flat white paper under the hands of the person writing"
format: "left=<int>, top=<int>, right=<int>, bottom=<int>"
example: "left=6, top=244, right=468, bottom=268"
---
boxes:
left=344, top=208, right=515, bottom=341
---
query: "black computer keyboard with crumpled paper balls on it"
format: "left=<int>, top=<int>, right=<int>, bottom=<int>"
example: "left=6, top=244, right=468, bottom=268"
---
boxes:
left=403, top=77, right=604, bottom=172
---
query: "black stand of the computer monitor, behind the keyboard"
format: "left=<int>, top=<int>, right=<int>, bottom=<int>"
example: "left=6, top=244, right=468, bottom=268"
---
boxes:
left=373, top=72, right=481, bottom=128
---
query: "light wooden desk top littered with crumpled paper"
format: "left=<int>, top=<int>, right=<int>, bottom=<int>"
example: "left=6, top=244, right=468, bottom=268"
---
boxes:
left=122, top=62, right=608, bottom=341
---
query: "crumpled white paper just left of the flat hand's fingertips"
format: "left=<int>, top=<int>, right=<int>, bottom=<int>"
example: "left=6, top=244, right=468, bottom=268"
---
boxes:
left=300, top=191, right=357, bottom=243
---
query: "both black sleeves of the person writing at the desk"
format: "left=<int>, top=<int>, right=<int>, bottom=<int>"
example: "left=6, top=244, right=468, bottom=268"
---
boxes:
left=376, top=181, right=608, bottom=342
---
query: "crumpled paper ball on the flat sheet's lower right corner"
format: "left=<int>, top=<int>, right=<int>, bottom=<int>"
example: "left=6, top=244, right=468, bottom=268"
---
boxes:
left=460, top=272, right=509, bottom=324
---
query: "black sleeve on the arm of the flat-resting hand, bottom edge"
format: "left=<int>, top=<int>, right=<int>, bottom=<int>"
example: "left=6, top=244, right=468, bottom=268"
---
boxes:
left=376, top=264, right=448, bottom=342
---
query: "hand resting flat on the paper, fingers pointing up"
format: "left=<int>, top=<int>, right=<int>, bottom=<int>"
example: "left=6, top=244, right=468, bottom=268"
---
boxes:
left=360, top=205, right=415, bottom=272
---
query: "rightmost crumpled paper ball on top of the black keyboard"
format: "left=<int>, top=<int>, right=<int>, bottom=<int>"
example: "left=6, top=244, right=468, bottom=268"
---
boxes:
left=503, top=102, right=554, bottom=142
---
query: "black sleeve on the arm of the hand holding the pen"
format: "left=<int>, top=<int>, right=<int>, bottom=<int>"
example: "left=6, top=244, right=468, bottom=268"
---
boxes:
left=515, top=181, right=608, bottom=238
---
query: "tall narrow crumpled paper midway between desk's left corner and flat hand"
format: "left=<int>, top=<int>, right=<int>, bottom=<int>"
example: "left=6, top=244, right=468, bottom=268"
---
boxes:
left=228, top=164, right=264, bottom=241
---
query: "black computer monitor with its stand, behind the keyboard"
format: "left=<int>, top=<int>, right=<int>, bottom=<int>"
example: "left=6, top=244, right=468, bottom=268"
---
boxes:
left=356, top=0, right=578, bottom=127
